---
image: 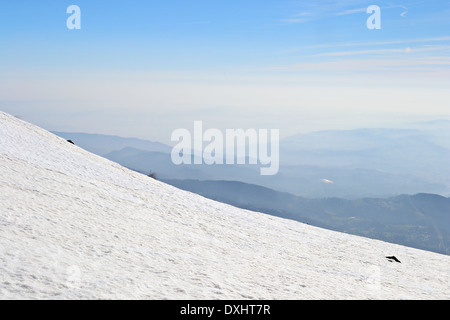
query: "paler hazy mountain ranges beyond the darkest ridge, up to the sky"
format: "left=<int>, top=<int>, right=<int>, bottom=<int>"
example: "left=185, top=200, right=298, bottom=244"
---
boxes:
left=54, top=120, right=450, bottom=199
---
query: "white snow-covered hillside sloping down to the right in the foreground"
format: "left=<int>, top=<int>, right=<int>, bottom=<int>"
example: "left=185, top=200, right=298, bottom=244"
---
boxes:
left=0, top=112, right=450, bottom=299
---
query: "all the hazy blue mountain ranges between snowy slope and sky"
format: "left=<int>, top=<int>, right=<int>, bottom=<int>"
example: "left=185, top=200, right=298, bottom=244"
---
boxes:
left=54, top=120, right=450, bottom=254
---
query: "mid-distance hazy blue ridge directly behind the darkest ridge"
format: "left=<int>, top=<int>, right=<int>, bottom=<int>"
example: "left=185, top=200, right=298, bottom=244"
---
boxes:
left=105, top=148, right=446, bottom=199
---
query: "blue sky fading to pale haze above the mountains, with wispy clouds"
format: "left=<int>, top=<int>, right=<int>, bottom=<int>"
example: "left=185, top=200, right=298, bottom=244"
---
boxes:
left=0, top=0, right=450, bottom=143
